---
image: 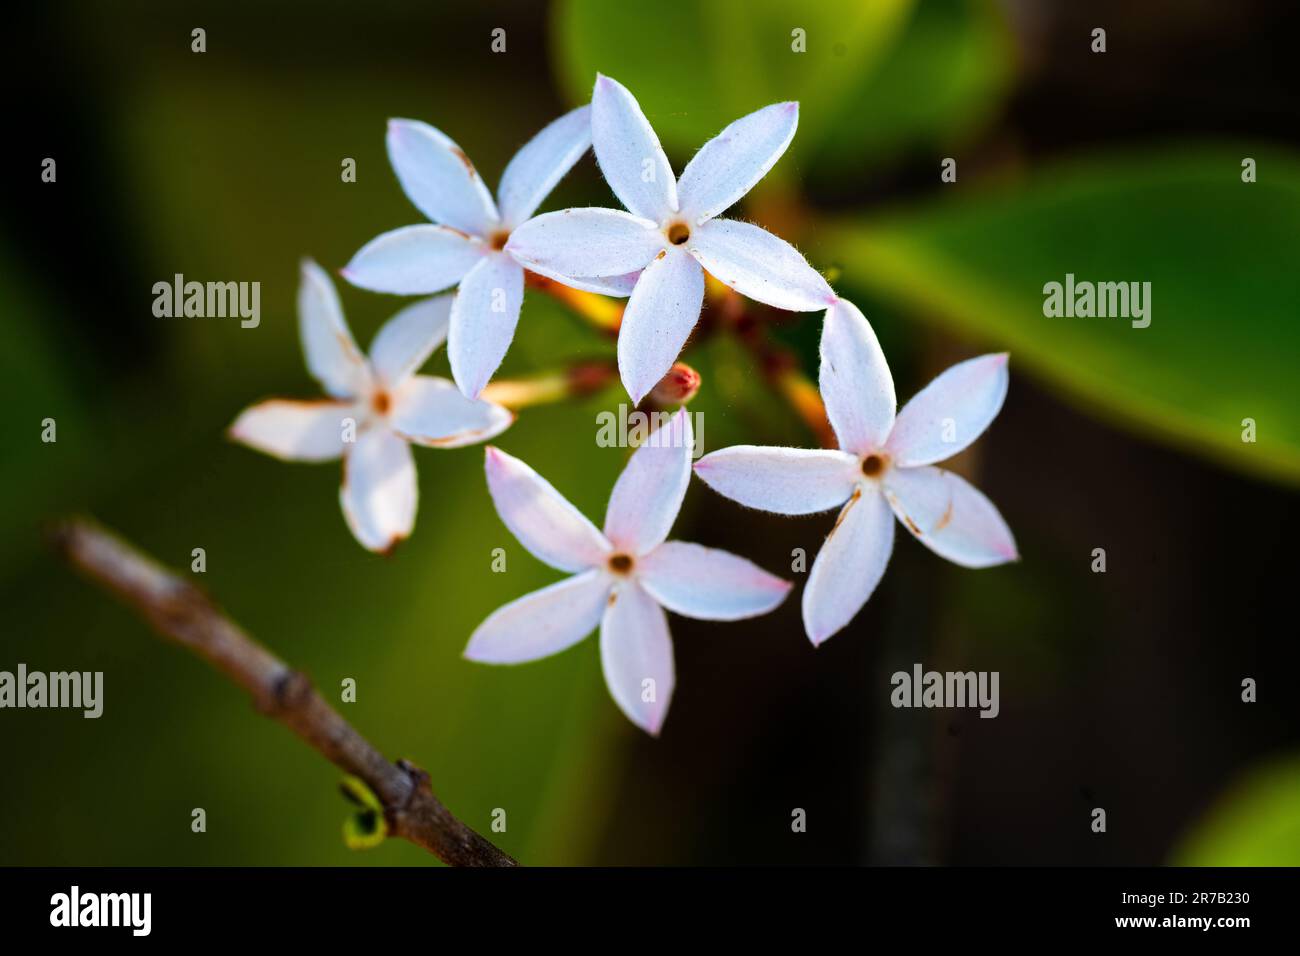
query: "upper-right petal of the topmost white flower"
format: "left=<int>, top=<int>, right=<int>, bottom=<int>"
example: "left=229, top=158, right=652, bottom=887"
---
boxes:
left=677, top=103, right=800, bottom=225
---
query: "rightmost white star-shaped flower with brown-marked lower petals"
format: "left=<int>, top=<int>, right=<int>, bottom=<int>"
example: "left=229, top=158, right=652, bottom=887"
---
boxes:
left=696, top=299, right=1018, bottom=644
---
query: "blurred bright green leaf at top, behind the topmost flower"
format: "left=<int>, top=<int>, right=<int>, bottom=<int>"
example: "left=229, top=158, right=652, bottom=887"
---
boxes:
left=551, top=0, right=915, bottom=170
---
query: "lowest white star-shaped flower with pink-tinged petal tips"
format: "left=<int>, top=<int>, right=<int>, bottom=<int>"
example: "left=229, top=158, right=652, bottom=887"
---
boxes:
left=465, top=411, right=790, bottom=734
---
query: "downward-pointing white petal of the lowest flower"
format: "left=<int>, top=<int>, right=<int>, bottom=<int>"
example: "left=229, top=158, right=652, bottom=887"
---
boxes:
left=601, top=583, right=676, bottom=735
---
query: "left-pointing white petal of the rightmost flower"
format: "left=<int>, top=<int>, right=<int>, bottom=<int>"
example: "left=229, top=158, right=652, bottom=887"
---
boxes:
left=696, top=445, right=862, bottom=515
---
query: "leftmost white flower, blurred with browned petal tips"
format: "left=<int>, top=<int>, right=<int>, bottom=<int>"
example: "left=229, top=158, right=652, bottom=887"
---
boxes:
left=230, top=260, right=514, bottom=551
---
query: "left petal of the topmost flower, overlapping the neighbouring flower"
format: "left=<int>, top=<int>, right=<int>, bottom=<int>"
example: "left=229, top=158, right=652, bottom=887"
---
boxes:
left=506, top=208, right=664, bottom=282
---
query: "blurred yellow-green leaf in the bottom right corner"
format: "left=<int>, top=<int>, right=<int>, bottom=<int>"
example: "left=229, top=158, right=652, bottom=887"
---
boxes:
left=1171, top=757, right=1300, bottom=866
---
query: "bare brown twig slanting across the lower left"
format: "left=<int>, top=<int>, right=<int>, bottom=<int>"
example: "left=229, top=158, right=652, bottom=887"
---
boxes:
left=51, top=518, right=516, bottom=866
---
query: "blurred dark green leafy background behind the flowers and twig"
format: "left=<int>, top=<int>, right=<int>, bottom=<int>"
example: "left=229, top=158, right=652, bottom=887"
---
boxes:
left=0, top=0, right=1300, bottom=865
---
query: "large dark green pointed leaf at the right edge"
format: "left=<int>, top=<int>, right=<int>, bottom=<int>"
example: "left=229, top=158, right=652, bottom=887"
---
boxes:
left=816, top=147, right=1300, bottom=481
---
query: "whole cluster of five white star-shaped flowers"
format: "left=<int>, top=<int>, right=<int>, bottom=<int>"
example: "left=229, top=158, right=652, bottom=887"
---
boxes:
left=231, top=75, right=1017, bottom=734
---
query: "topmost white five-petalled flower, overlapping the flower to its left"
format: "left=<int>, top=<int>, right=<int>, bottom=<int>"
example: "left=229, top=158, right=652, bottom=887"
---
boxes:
left=506, top=75, right=835, bottom=402
